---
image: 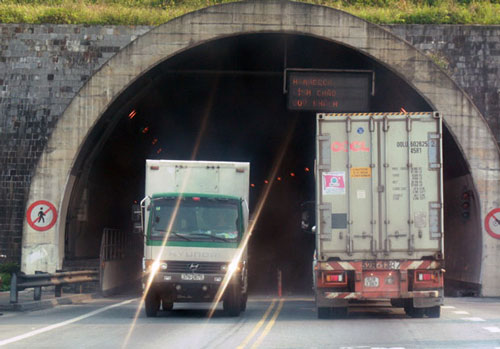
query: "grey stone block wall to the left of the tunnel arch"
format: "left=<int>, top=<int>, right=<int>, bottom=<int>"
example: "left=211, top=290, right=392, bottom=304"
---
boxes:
left=0, top=24, right=150, bottom=261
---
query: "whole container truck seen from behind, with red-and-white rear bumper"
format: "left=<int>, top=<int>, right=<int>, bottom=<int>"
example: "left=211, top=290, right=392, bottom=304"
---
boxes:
left=310, top=112, right=444, bottom=318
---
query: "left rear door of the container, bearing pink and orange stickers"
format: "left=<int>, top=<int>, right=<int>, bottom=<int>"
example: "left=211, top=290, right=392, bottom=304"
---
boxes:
left=316, top=116, right=380, bottom=258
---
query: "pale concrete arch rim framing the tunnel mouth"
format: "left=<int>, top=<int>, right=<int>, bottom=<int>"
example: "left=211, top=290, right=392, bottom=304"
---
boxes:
left=22, top=1, right=500, bottom=296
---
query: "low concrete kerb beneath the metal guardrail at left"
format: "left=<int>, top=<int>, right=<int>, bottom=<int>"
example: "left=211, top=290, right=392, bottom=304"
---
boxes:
left=0, top=290, right=101, bottom=311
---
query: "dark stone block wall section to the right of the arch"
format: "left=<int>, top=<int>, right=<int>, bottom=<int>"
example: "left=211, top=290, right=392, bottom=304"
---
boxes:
left=385, top=25, right=500, bottom=142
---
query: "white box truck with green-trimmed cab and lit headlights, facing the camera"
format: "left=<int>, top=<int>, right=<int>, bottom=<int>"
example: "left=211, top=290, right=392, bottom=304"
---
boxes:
left=141, top=160, right=250, bottom=317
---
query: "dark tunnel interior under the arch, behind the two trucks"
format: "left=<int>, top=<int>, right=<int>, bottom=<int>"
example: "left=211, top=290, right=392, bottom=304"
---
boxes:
left=63, top=33, right=481, bottom=293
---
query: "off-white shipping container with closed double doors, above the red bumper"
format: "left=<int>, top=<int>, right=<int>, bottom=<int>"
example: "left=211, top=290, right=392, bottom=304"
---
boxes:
left=316, top=112, right=443, bottom=260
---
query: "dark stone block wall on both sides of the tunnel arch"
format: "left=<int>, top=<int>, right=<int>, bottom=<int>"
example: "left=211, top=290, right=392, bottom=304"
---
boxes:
left=0, top=24, right=500, bottom=261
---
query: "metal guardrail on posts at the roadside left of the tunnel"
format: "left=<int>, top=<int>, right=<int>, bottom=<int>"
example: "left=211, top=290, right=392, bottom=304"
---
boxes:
left=10, top=270, right=99, bottom=303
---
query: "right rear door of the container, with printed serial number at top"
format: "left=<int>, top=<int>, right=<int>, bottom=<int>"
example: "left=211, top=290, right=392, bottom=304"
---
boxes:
left=381, top=113, right=443, bottom=257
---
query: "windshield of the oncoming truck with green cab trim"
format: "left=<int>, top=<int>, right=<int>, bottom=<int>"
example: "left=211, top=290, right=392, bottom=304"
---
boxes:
left=151, top=197, right=240, bottom=242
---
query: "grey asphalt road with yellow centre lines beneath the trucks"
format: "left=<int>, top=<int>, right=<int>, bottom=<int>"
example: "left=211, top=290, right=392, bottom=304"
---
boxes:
left=0, top=296, right=500, bottom=349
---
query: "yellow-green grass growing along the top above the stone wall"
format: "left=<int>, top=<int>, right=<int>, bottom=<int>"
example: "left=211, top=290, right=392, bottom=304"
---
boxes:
left=0, top=0, right=500, bottom=25
